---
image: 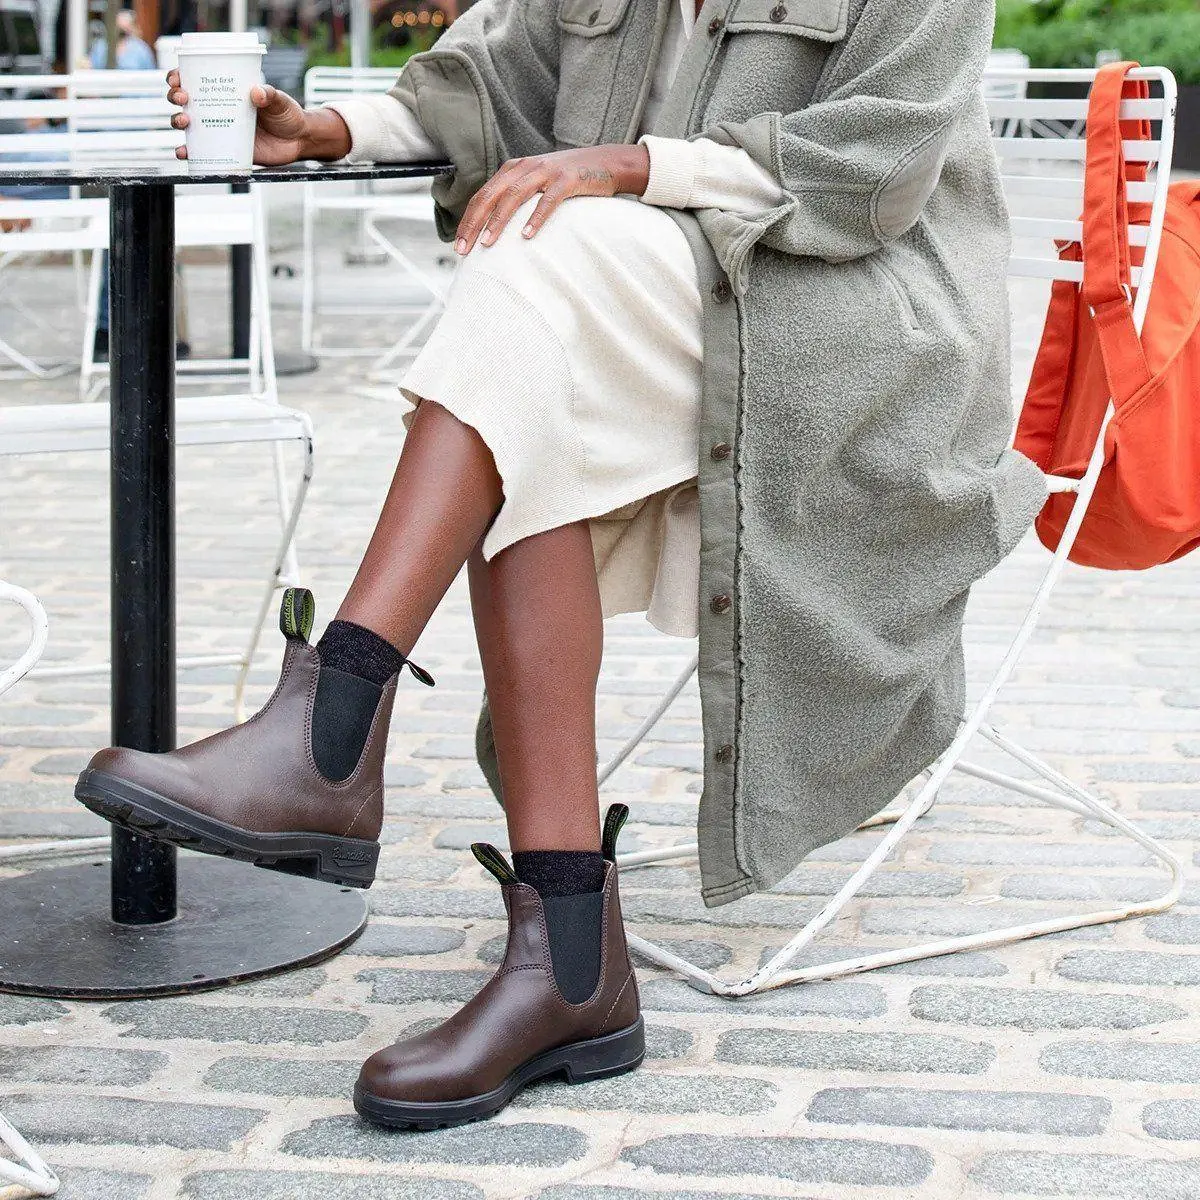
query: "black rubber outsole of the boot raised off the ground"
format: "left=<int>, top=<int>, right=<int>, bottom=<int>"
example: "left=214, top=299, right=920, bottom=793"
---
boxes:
left=76, top=769, right=379, bottom=888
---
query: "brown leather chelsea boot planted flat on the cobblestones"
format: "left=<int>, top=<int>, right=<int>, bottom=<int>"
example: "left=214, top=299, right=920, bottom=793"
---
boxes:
left=354, top=804, right=646, bottom=1129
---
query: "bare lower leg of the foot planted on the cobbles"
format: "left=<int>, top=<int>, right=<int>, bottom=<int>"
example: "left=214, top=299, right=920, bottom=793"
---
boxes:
left=469, top=522, right=604, bottom=851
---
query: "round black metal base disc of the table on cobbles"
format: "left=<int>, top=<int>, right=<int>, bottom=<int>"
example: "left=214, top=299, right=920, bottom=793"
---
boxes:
left=0, top=854, right=367, bottom=1000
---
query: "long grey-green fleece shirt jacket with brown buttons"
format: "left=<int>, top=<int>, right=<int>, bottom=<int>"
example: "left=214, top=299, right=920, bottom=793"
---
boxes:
left=396, top=0, right=1045, bottom=905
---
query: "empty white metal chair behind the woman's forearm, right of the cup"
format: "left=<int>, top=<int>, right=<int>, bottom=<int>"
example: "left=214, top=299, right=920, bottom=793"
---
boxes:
left=300, top=67, right=445, bottom=378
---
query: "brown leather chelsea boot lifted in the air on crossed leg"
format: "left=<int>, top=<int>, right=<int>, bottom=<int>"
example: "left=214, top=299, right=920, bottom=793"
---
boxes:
left=76, top=588, right=432, bottom=888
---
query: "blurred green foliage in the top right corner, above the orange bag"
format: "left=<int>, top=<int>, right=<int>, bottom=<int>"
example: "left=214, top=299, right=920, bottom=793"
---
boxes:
left=996, top=0, right=1200, bottom=84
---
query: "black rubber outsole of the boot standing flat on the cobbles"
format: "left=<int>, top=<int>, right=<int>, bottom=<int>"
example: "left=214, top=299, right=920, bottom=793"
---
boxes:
left=354, top=1016, right=646, bottom=1129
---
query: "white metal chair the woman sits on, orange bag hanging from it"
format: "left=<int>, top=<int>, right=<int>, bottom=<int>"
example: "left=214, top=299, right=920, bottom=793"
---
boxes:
left=614, top=68, right=1182, bottom=996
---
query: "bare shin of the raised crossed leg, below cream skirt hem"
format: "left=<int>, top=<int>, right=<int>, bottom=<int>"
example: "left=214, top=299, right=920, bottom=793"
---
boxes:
left=337, top=401, right=504, bottom=654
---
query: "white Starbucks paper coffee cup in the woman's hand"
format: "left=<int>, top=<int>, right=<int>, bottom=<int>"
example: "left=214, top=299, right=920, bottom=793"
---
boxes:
left=178, top=34, right=266, bottom=170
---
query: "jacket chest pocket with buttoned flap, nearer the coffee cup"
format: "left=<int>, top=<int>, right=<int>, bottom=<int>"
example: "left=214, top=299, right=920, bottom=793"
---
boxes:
left=554, top=0, right=630, bottom=146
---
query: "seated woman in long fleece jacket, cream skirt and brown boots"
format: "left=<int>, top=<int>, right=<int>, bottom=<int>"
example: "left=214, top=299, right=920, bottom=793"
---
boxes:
left=77, top=0, right=1044, bottom=1127
